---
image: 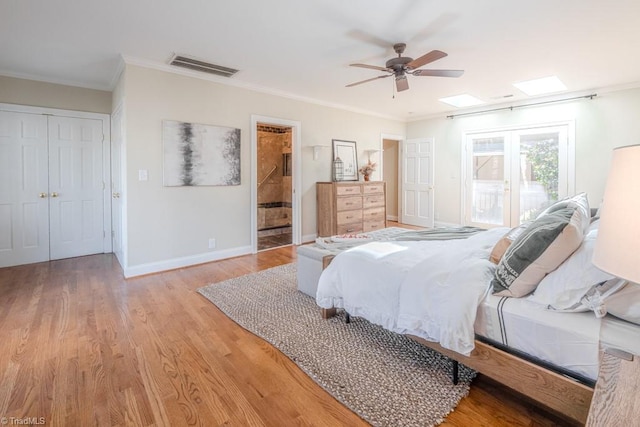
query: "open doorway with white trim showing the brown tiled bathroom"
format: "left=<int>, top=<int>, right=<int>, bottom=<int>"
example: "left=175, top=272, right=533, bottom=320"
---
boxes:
left=252, top=116, right=300, bottom=253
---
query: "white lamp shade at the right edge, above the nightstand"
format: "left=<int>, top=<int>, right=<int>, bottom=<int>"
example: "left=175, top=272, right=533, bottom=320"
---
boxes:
left=593, top=145, right=640, bottom=283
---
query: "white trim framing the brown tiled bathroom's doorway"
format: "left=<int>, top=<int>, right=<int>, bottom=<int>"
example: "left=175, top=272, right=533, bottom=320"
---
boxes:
left=251, top=114, right=302, bottom=253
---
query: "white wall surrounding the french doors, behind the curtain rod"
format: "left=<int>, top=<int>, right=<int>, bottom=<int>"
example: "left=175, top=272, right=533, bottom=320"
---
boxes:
left=407, top=89, right=640, bottom=224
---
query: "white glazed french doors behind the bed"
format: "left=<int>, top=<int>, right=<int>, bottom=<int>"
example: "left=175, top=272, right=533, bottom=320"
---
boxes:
left=464, top=123, right=574, bottom=228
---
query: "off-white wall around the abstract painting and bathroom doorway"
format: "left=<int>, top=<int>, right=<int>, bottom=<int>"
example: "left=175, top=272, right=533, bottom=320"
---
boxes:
left=118, top=65, right=405, bottom=274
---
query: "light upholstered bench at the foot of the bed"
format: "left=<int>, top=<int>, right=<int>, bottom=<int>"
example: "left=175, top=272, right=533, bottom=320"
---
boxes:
left=297, top=227, right=408, bottom=298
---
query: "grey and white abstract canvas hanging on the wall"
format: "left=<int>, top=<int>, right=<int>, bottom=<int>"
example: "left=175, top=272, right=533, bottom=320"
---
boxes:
left=162, top=120, right=240, bottom=187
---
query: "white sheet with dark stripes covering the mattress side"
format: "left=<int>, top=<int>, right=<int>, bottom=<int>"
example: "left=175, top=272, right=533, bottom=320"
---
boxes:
left=474, top=295, right=601, bottom=380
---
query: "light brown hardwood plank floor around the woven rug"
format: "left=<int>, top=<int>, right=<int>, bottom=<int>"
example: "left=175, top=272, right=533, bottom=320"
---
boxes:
left=0, top=247, right=576, bottom=426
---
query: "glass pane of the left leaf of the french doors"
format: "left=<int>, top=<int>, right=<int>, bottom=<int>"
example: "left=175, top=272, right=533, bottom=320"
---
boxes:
left=471, top=136, right=505, bottom=225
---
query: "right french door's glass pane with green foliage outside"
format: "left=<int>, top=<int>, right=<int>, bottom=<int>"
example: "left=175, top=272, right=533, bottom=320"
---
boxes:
left=519, top=132, right=559, bottom=223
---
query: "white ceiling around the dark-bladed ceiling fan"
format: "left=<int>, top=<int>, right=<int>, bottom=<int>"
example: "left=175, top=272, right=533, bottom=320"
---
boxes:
left=0, top=0, right=640, bottom=120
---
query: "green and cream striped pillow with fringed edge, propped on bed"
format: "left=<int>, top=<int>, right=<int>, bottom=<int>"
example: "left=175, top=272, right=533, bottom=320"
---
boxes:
left=491, top=193, right=589, bottom=297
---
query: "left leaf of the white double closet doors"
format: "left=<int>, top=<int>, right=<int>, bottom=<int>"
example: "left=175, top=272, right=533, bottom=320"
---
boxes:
left=0, top=111, right=49, bottom=267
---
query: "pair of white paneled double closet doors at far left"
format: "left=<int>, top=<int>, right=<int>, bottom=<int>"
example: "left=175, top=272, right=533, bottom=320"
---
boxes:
left=0, top=111, right=110, bottom=267
